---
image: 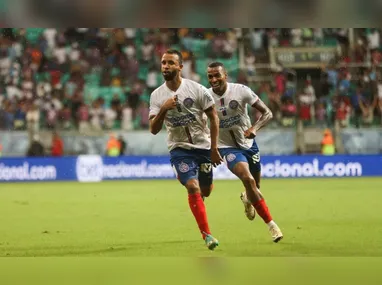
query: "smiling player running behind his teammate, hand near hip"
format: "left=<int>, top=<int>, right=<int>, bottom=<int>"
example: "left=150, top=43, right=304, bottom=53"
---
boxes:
left=207, top=62, right=283, bottom=242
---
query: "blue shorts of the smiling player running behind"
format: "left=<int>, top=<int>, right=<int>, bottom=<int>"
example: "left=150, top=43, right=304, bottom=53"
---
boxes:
left=219, top=140, right=261, bottom=175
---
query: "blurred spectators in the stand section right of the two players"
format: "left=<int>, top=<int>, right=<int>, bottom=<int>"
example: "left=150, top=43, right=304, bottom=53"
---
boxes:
left=243, top=28, right=382, bottom=127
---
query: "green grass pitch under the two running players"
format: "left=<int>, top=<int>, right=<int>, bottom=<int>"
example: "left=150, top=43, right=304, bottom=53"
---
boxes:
left=0, top=178, right=382, bottom=257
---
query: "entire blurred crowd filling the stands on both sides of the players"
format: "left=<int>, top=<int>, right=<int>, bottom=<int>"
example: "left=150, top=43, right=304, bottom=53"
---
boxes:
left=0, top=28, right=382, bottom=132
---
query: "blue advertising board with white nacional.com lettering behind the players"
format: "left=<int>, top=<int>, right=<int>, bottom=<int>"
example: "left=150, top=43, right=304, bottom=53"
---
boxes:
left=0, top=155, right=382, bottom=182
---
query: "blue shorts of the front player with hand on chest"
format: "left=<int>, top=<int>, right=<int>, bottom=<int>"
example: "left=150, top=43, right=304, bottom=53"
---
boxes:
left=170, top=148, right=213, bottom=187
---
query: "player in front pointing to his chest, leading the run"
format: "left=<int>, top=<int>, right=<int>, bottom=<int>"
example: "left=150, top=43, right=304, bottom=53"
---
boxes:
left=149, top=50, right=223, bottom=250
